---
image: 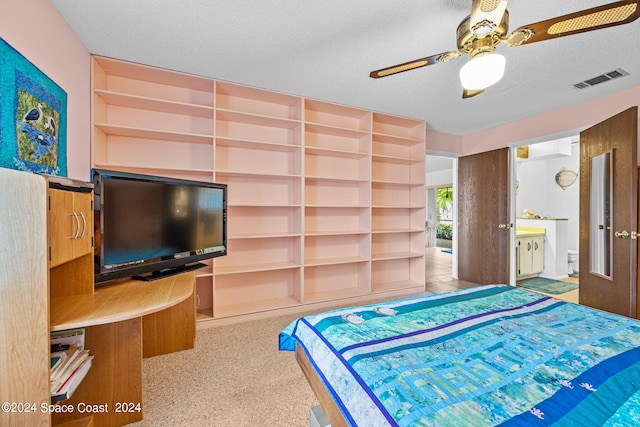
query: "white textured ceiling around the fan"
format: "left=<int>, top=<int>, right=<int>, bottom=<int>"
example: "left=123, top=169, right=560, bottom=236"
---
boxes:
left=51, top=0, right=640, bottom=135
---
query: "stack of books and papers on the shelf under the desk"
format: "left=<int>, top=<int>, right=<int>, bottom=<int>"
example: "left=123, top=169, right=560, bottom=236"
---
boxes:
left=49, top=329, right=93, bottom=404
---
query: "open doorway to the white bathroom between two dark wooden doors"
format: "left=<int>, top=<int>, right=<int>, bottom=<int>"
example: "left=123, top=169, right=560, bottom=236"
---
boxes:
left=512, top=135, right=580, bottom=303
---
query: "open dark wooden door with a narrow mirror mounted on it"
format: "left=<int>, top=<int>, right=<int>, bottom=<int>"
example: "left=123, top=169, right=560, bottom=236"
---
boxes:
left=579, top=107, right=638, bottom=317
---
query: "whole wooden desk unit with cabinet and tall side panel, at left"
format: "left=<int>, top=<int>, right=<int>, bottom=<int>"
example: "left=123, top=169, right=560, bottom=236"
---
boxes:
left=0, top=168, right=195, bottom=426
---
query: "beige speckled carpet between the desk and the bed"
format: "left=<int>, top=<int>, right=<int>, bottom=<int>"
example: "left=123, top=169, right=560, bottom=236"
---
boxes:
left=131, top=315, right=317, bottom=427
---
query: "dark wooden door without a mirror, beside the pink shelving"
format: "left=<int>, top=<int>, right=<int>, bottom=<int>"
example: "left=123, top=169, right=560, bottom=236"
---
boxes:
left=458, top=148, right=511, bottom=284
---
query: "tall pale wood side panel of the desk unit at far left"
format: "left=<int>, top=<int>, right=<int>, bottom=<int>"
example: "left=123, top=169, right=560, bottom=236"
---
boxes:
left=0, top=168, right=51, bottom=426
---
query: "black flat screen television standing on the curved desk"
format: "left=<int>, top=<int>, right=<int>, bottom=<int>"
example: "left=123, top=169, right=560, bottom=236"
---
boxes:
left=91, top=169, right=227, bottom=284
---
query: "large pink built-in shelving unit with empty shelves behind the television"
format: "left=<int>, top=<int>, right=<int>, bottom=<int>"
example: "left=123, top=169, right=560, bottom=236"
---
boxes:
left=92, top=56, right=426, bottom=322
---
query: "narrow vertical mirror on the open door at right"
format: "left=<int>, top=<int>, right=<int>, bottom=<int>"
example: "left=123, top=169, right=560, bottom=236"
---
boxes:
left=589, top=151, right=613, bottom=278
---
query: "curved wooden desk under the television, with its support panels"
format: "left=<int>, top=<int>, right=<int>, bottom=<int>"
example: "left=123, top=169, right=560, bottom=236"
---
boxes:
left=51, top=272, right=195, bottom=426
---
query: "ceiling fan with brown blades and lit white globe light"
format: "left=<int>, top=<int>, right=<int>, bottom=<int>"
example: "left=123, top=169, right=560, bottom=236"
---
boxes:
left=369, top=0, right=640, bottom=98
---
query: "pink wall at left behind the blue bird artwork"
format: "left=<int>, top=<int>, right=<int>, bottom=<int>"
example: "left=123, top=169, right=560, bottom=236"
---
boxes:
left=0, top=0, right=91, bottom=180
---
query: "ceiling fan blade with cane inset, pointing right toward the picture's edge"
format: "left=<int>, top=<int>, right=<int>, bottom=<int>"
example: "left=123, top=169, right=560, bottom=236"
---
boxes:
left=506, top=0, right=640, bottom=46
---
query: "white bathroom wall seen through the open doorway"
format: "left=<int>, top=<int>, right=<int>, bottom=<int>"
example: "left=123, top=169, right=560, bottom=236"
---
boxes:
left=516, top=143, right=580, bottom=251
